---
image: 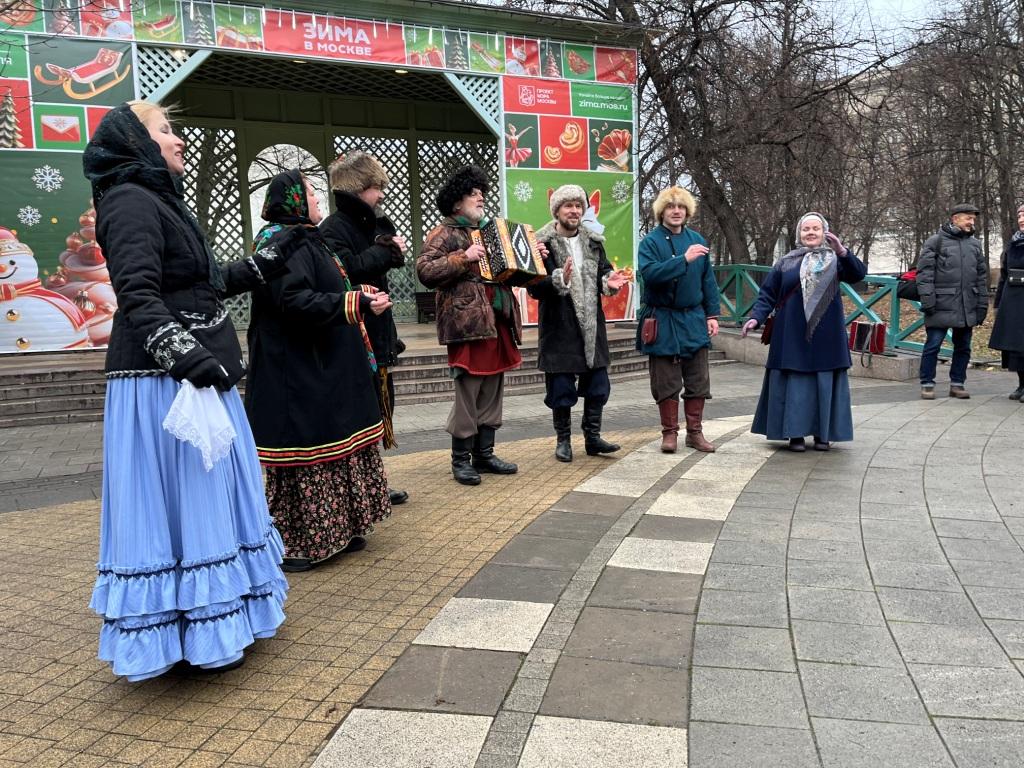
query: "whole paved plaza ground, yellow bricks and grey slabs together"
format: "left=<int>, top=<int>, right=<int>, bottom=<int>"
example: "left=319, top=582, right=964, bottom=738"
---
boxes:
left=0, top=365, right=1024, bottom=768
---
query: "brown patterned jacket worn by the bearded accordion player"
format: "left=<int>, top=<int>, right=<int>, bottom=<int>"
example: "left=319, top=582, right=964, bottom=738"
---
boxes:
left=416, top=217, right=522, bottom=345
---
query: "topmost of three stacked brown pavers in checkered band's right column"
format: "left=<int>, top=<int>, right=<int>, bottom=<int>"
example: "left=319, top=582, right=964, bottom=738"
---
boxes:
left=587, top=566, right=707, bottom=613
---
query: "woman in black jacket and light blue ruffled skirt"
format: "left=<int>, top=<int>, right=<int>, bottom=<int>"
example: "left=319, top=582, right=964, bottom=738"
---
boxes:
left=84, top=101, right=288, bottom=681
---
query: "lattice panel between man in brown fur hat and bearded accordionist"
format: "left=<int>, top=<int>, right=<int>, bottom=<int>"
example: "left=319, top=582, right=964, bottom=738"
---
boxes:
left=334, top=136, right=418, bottom=322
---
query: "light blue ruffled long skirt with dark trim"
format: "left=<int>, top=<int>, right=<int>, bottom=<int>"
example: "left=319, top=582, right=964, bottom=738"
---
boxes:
left=90, top=376, right=288, bottom=681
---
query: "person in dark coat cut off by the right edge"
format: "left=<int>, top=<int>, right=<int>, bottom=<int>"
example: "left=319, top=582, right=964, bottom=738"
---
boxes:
left=988, top=201, right=1024, bottom=400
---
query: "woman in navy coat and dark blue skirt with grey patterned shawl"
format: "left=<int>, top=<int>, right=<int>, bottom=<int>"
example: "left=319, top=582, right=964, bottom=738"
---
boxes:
left=743, top=212, right=867, bottom=451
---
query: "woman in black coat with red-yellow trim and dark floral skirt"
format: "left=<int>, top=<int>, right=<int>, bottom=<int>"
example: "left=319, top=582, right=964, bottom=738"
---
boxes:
left=246, top=170, right=391, bottom=571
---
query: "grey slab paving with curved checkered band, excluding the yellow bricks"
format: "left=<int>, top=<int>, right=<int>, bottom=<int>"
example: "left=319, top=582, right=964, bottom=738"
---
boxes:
left=314, top=370, right=1024, bottom=768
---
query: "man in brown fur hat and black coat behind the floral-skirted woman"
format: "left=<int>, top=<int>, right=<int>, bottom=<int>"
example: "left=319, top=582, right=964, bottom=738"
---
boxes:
left=321, top=152, right=409, bottom=504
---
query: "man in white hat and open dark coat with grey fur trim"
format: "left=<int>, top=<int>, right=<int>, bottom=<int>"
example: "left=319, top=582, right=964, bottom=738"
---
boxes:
left=527, top=184, right=628, bottom=462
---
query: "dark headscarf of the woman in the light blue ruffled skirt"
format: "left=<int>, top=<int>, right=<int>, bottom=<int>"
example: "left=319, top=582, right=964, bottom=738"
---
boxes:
left=82, top=103, right=224, bottom=291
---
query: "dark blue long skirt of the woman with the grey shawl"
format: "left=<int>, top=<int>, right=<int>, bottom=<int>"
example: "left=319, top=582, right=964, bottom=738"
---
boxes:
left=751, top=369, right=853, bottom=442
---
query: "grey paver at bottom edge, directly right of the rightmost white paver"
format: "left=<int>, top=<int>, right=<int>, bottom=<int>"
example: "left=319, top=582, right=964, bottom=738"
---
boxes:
left=689, top=722, right=821, bottom=768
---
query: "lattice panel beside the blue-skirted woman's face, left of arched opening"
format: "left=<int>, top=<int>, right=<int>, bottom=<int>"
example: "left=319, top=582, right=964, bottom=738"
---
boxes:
left=180, top=125, right=249, bottom=328
